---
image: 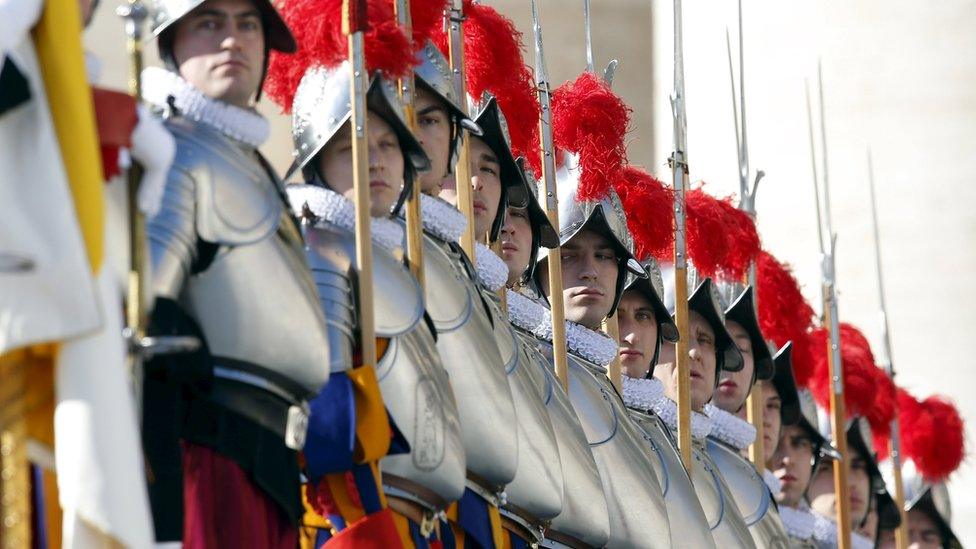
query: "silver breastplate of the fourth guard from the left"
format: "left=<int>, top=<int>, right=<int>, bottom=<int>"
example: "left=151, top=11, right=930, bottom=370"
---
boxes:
left=484, top=292, right=563, bottom=525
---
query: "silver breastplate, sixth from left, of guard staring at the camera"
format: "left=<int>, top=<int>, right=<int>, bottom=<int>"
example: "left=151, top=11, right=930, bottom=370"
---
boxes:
left=552, top=344, right=671, bottom=547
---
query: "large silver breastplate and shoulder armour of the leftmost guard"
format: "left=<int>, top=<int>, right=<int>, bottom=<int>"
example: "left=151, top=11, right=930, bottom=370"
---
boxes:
left=147, top=118, right=329, bottom=392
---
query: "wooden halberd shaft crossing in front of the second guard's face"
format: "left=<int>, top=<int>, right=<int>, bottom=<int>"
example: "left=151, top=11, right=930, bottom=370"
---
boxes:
left=342, top=0, right=376, bottom=366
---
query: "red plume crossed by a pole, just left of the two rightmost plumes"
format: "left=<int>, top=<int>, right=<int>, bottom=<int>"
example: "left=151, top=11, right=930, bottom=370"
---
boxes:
left=808, top=323, right=878, bottom=417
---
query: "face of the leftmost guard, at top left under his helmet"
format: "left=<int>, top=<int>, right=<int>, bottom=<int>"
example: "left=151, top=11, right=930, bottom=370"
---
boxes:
left=173, top=0, right=265, bottom=107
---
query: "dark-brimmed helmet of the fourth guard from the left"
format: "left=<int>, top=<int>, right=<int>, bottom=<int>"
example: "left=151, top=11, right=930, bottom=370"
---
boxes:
left=468, top=94, right=529, bottom=242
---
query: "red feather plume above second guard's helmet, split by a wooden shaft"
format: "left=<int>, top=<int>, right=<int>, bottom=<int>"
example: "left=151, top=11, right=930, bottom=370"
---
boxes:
left=264, top=0, right=414, bottom=113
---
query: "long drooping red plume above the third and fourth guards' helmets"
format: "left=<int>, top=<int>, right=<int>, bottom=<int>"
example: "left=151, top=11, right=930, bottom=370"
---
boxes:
left=435, top=0, right=542, bottom=174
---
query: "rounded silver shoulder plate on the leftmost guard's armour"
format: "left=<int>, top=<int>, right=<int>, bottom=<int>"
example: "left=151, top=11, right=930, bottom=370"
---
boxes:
left=166, top=118, right=283, bottom=246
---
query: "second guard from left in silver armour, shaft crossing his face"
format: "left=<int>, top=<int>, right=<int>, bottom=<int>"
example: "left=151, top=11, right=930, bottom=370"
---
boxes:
left=278, top=45, right=465, bottom=537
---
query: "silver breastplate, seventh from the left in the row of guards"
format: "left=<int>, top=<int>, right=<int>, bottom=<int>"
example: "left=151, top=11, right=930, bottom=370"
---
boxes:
left=630, top=410, right=715, bottom=548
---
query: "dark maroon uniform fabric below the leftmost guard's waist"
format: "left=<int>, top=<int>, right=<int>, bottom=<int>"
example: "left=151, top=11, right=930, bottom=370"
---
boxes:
left=183, top=442, right=298, bottom=549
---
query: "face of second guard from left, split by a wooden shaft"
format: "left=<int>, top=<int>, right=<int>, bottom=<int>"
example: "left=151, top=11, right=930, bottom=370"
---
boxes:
left=318, top=111, right=403, bottom=217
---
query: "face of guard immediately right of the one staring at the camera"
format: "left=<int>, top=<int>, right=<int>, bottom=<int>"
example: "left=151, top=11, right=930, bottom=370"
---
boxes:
left=617, top=290, right=657, bottom=378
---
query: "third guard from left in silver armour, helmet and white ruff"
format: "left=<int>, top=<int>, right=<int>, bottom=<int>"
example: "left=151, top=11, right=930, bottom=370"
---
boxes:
left=416, top=39, right=519, bottom=544
